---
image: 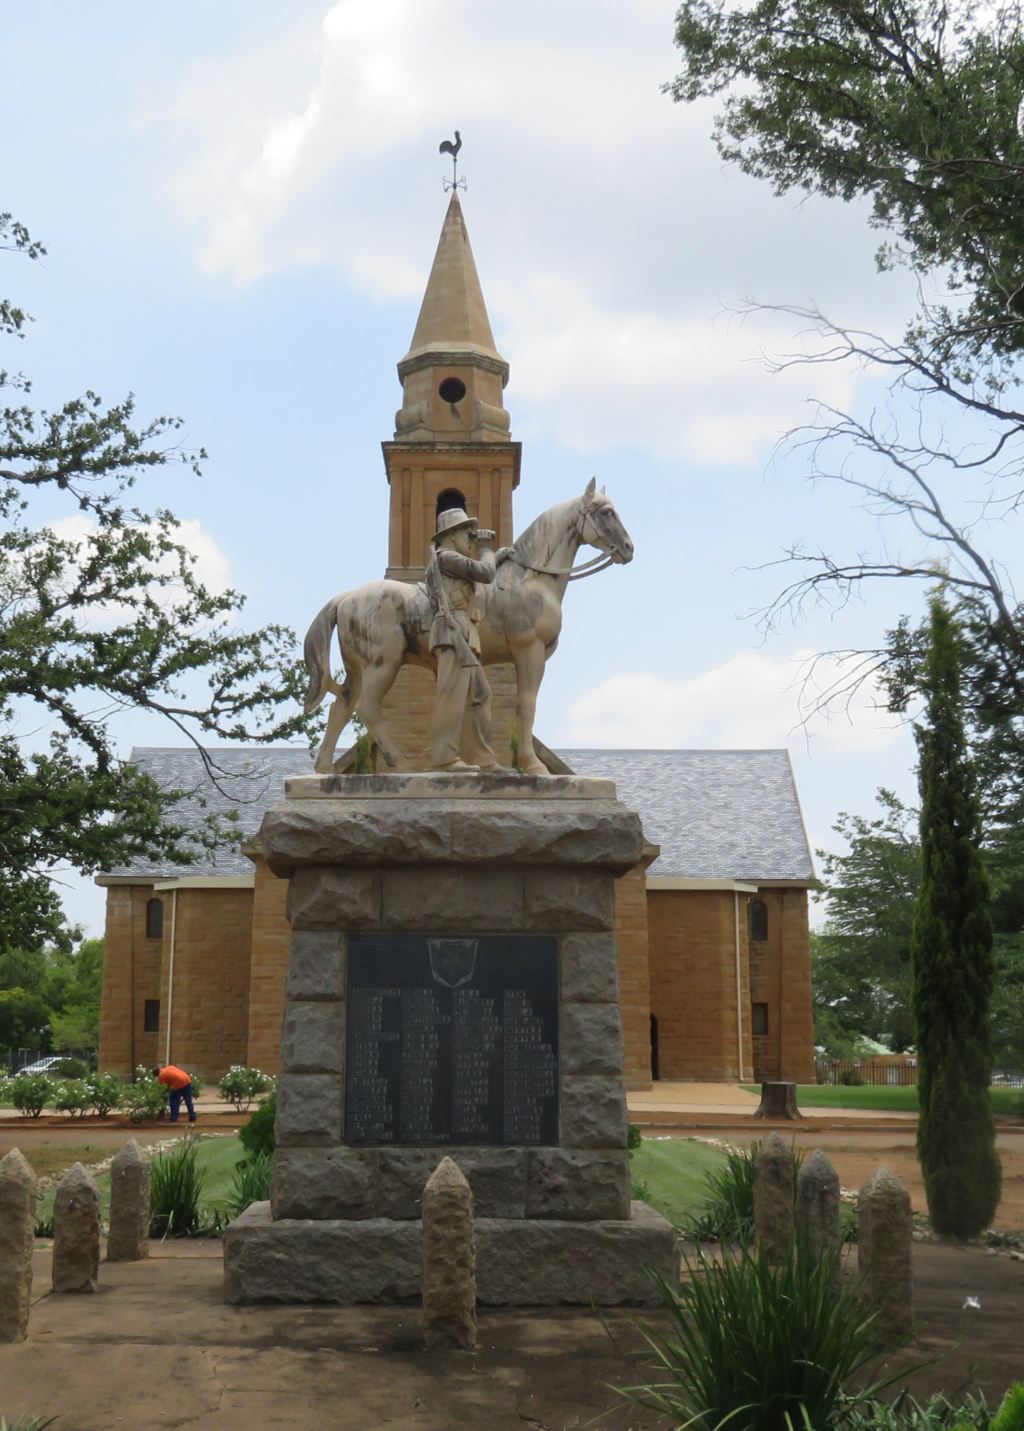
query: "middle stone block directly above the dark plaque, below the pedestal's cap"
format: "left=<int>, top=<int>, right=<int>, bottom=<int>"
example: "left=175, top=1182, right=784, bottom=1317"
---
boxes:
left=383, top=866, right=523, bottom=934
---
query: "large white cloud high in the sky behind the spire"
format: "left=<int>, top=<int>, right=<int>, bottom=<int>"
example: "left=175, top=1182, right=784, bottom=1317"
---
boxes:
left=148, top=0, right=915, bottom=462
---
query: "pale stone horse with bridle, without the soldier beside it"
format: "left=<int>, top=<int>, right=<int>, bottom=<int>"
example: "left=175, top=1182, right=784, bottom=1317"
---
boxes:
left=303, top=479, right=634, bottom=776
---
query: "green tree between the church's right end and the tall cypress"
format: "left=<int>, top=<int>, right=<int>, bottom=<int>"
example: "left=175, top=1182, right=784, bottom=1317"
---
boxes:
left=812, top=790, right=921, bottom=1053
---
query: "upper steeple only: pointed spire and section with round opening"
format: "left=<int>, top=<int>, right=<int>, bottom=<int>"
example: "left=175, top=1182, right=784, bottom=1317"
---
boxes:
left=395, top=192, right=509, bottom=442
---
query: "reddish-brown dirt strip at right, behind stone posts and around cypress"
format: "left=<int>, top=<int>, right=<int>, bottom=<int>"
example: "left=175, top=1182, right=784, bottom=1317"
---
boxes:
left=715, top=1123, right=1024, bottom=1230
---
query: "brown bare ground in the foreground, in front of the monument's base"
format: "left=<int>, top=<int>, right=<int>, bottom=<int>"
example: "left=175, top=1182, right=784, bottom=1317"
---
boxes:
left=0, top=1242, right=1024, bottom=1431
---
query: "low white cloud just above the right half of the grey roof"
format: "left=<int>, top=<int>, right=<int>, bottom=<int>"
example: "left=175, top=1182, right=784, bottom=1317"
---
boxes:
left=562, top=650, right=902, bottom=754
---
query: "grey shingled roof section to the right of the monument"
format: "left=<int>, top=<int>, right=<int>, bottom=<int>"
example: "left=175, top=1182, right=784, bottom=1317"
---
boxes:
left=558, top=750, right=814, bottom=883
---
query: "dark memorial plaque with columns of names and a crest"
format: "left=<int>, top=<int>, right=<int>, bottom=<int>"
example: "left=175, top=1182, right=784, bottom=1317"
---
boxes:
left=345, top=934, right=558, bottom=1145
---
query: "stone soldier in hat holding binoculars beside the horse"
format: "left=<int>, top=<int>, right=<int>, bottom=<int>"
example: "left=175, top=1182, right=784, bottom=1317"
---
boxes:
left=425, top=507, right=502, bottom=770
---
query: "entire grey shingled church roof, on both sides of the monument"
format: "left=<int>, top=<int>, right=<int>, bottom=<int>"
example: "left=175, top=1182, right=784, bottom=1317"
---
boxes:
left=110, top=746, right=814, bottom=883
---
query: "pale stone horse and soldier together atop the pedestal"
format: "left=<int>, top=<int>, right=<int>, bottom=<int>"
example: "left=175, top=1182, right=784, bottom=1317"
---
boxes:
left=305, top=479, right=634, bottom=776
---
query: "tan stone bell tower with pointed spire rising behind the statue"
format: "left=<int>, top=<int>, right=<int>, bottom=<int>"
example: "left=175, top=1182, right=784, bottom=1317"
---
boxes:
left=382, top=190, right=521, bottom=581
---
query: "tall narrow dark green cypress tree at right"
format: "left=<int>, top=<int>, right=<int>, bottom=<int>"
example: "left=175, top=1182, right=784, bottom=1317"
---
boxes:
left=911, top=597, right=1001, bottom=1238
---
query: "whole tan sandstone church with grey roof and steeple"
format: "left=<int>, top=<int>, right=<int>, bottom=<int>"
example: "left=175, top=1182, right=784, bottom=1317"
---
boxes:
left=97, top=192, right=814, bottom=1089
